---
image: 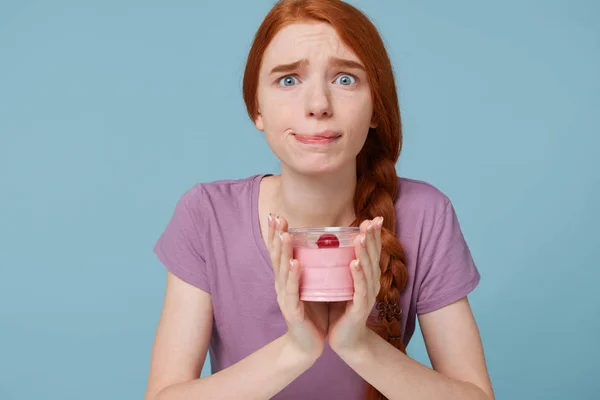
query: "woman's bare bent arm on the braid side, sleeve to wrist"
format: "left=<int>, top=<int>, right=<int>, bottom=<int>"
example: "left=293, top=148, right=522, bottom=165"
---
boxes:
left=339, top=297, right=494, bottom=400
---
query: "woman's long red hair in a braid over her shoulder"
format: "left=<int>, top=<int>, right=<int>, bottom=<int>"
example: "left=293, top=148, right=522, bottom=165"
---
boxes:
left=243, top=0, right=408, bottom=400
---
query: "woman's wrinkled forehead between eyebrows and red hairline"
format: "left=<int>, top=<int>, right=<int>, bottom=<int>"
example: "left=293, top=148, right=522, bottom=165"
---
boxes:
left=263, top=22, right=359, bottom=68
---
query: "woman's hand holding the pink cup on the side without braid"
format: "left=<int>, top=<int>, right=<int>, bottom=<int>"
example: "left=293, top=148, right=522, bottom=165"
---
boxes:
left=268, top=214, right=329, bottom=360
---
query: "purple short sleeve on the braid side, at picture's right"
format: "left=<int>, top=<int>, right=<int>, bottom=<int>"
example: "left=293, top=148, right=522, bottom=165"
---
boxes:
left=417, top=200, right=481, bottom=314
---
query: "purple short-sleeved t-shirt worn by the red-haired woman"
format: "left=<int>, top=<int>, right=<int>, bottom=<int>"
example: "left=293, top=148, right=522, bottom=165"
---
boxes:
left=154, top=175, right=480, bottom=400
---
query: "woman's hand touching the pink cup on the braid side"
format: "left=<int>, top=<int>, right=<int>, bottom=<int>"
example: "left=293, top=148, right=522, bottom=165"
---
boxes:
left=328, top=217, right=383, bottom=353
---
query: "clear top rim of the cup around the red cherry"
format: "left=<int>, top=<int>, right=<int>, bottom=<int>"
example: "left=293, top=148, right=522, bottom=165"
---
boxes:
left=288, top=226, right=360, bottom=249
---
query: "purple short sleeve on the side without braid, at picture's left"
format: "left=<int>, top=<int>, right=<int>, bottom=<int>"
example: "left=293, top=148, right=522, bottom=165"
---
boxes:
left=154, top=185, right=210, bottom=293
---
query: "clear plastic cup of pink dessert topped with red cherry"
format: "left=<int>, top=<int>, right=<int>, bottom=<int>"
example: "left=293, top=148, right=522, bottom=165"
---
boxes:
left=288, top=227, right=360, bottom=302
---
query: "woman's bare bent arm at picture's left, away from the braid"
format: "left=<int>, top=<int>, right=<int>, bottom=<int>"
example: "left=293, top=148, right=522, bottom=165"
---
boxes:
left=145, top=272, right=315, bottom=400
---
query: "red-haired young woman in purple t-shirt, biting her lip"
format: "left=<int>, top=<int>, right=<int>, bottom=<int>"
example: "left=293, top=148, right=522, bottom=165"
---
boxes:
left=146, top=0, right=494, bottom=400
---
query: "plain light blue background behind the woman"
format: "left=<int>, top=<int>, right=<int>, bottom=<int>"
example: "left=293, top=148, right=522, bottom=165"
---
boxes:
left=0, top=0, right=600, bottom=400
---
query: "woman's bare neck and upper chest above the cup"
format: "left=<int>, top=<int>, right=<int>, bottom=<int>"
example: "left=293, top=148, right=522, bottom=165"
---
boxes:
left=273, top=166, right=356, bottom=228
